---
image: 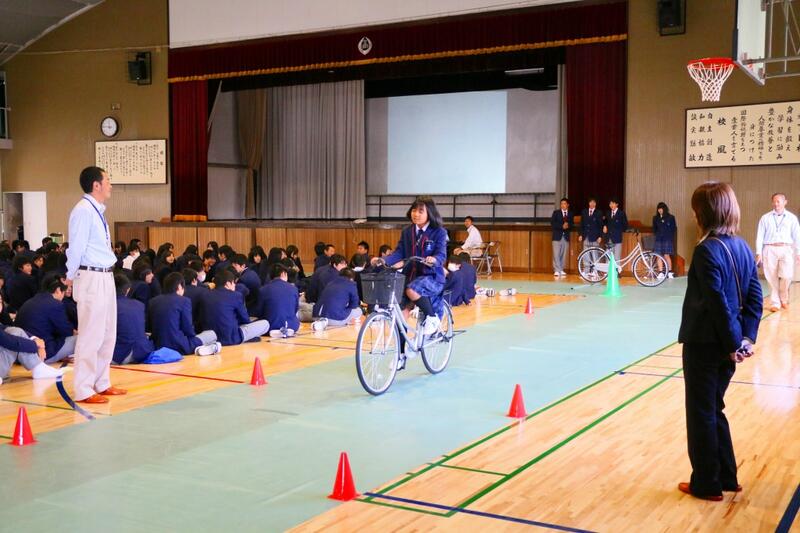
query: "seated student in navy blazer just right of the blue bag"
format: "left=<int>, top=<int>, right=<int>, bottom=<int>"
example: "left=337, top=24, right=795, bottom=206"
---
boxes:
left=147, top=272, right=222, bottom=355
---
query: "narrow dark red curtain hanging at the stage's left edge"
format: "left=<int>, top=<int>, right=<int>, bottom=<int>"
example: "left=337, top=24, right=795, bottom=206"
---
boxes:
left=170, top=80, right=208, bottom=216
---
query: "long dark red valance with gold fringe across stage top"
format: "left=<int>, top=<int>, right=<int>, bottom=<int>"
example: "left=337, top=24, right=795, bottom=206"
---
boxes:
left=168, top=1, right=628, bottom=82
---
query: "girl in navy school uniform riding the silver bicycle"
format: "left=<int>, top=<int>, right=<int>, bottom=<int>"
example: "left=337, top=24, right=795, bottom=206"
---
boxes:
left=372, top=196, right=447, bottom=335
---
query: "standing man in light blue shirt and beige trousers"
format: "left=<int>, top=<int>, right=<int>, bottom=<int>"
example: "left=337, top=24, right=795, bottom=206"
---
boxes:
left=67, top=167, right=127, bottom=403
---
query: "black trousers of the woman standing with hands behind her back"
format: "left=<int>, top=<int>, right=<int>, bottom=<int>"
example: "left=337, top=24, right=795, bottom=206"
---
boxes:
left=683, top=344, right=737, bottom=496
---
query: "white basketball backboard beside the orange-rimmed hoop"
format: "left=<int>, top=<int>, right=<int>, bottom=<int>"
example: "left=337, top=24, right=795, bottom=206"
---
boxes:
left=733, top=0, right=768, bottom=85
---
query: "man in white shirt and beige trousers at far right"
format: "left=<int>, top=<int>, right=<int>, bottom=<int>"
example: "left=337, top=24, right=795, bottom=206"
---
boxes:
left=756, top=193, right=800, bottom=312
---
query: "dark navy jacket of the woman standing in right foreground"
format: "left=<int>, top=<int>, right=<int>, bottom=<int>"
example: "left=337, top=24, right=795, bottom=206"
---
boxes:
left=678, top=235, right=763, bottom=353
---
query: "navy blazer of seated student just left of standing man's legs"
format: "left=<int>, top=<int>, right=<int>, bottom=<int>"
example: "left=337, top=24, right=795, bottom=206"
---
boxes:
left=14, top=292, right=73, bottom=357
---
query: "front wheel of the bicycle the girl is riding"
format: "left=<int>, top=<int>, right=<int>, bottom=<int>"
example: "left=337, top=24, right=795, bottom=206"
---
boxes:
left=356, top=312, right=400, bottom=396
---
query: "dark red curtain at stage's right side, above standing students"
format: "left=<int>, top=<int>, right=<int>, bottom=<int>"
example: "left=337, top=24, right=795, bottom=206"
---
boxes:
left=566, top=41, right=627, bottom=213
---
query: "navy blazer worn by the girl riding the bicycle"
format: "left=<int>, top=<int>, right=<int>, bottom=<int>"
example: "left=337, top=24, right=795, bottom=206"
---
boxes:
left=384, top=224, right=447, bottom=284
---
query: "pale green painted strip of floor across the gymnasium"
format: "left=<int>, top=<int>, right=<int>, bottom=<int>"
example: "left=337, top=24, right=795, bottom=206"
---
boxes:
left=0, top=280, right=685, bottom=532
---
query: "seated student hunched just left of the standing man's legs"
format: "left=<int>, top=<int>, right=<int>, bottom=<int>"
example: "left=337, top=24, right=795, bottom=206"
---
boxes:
left=14, top=274, right=77, bottom=363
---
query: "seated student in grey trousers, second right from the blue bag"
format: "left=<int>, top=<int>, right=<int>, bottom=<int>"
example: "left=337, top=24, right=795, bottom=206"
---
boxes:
left=201, top=270, right=269, bottom=346
